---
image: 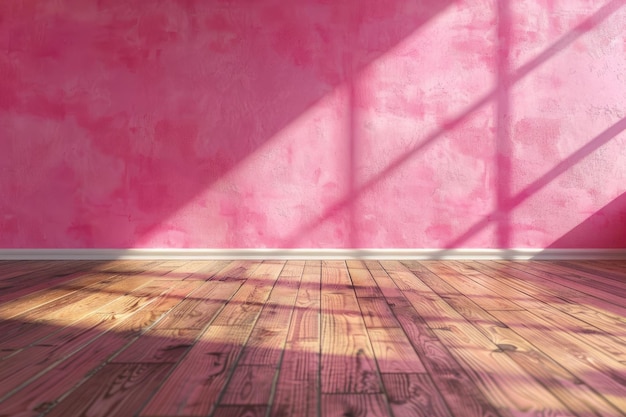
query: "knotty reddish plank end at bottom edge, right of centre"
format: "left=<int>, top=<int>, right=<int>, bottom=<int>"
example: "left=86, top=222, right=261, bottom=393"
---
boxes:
left=382, top=373, right=452, bottom=417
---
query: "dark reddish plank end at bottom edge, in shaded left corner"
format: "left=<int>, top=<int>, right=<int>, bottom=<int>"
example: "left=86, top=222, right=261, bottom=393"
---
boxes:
left=46, top=363, right=172, bottom=417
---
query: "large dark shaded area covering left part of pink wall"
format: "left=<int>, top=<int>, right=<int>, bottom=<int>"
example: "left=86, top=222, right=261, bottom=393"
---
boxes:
left=0, top=0, right=453, bottom=247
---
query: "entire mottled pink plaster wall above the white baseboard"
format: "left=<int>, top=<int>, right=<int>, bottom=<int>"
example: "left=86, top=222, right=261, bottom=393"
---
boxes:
left=0, top=0, right=626, bottom=248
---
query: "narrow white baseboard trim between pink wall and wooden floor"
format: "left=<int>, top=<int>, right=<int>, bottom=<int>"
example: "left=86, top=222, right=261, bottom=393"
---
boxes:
left=0, top=248, right=626, bottom=260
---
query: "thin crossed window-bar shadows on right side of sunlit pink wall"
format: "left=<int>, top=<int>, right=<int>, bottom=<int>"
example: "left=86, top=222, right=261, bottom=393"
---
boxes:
left=283, top=0, right=626, bottom=249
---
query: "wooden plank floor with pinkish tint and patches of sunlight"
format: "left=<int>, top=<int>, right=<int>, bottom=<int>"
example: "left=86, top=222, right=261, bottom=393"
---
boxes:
left=0, top=261, right=626, bottom=417
